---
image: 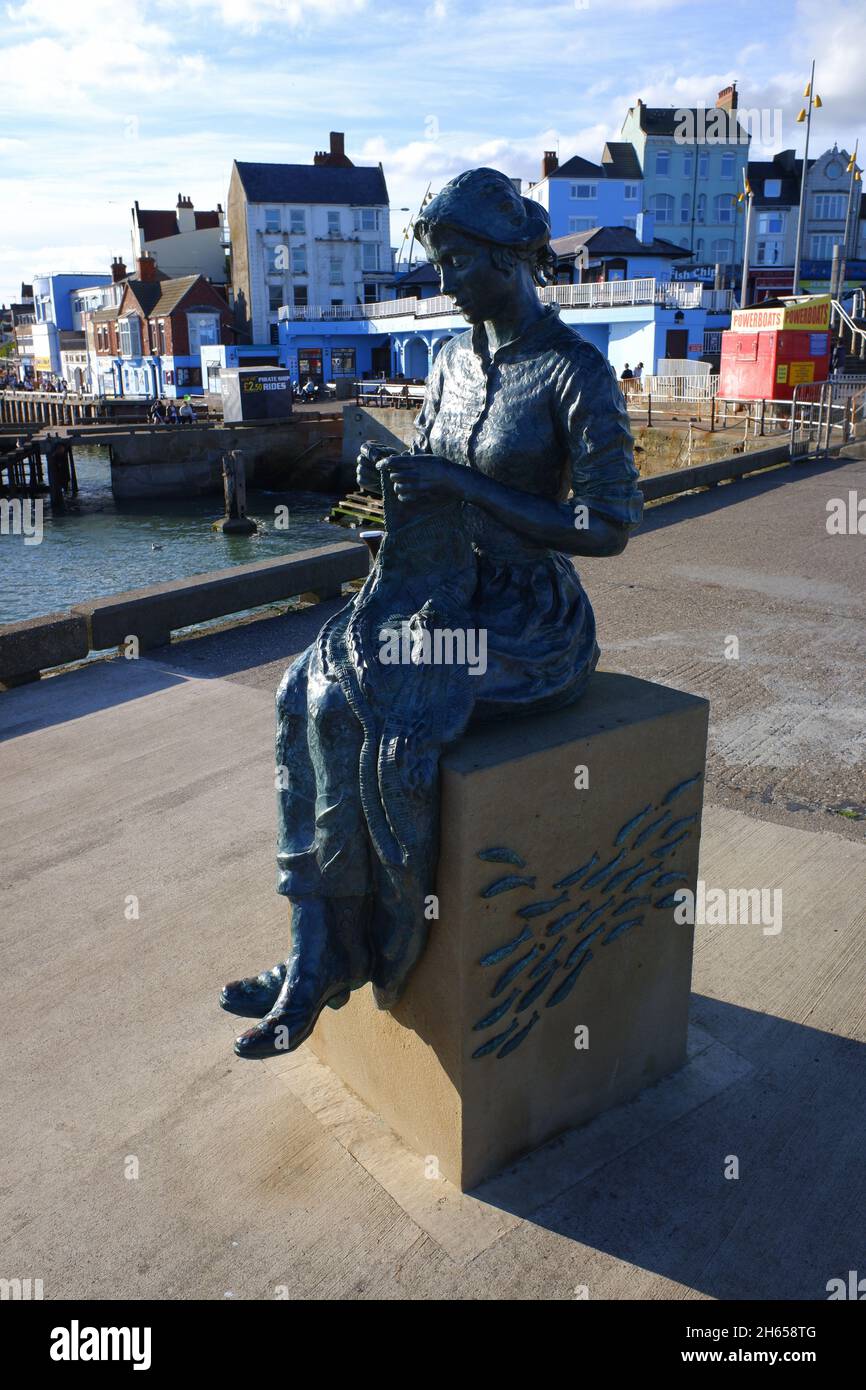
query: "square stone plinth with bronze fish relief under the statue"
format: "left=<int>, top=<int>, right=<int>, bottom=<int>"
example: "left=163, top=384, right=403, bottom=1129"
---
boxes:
left=310, top=673, right=709, bottom=1190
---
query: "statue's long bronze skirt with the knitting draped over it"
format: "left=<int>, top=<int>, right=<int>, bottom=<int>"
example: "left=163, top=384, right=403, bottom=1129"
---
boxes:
left=277, top=506, right=599, bottom=1008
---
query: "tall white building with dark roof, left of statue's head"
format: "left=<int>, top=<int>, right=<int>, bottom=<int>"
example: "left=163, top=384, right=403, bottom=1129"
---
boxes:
left=228, top=131, right=393, bottom=343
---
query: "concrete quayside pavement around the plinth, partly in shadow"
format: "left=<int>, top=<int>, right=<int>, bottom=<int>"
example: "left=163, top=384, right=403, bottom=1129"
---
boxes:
left=0, top=450, right=866, bottom=1300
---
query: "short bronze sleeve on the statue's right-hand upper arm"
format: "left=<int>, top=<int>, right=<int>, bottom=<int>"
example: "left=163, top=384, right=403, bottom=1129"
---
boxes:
left=556, top=342, right=644, bottom=528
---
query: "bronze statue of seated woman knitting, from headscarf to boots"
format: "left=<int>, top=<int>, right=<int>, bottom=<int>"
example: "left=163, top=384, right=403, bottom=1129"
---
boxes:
left=220, top=168, right=642, bottom=1056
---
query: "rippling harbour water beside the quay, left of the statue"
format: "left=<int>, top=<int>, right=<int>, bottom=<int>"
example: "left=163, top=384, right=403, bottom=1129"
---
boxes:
left=0, top=446, right=342, bottom=623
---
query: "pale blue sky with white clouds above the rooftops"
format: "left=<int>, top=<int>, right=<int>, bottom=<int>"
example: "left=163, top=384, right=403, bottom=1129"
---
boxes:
left=0, top=0, right=866, bottom=302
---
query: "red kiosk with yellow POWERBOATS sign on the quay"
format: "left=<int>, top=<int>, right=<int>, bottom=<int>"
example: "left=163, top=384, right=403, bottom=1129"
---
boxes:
left=719, top=295, right=830, bottom=400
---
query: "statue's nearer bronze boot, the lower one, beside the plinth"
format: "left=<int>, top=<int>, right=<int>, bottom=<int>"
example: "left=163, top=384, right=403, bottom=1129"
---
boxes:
left=235, top=898, right=371, bottom=1056
